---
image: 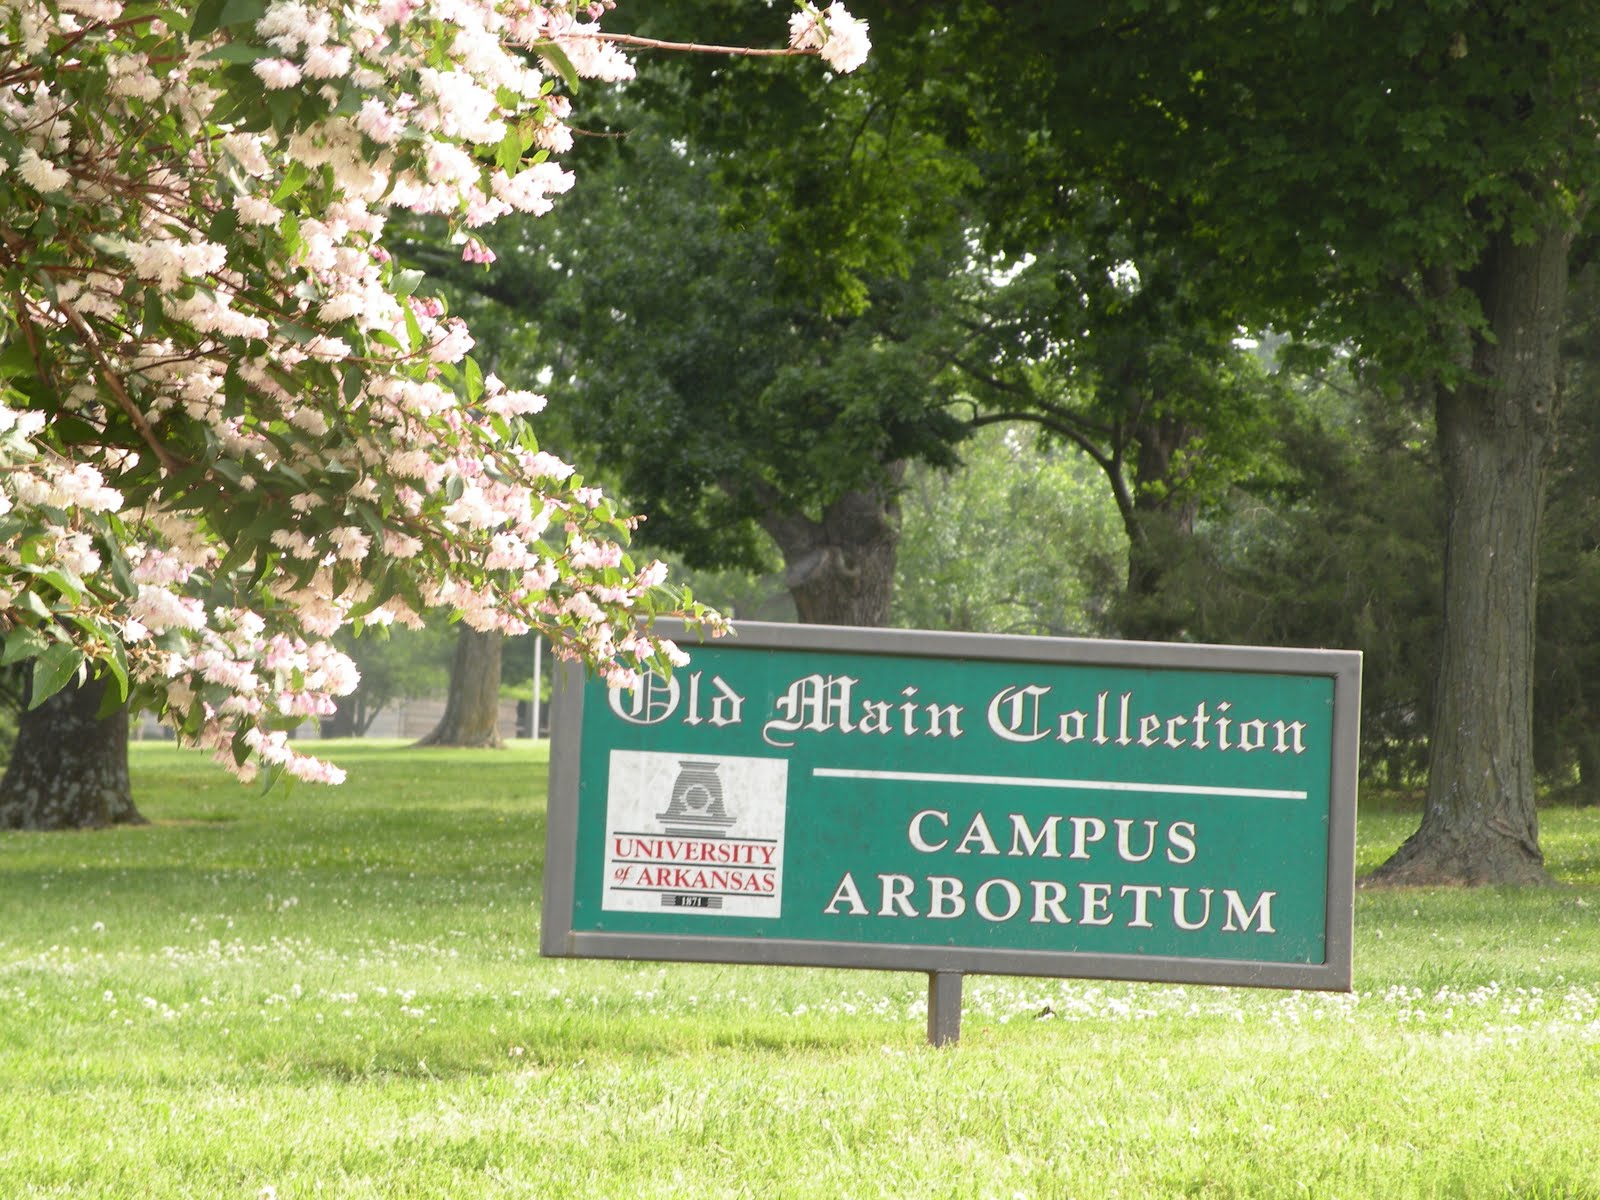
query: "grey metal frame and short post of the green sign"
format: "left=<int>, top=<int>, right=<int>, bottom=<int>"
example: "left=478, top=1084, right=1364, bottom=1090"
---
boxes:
left=539, top=622, right=1362, bottom=1042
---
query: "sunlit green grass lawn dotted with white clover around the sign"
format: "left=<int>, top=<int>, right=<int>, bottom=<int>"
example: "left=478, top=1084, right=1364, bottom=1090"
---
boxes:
left=0, top=742, right=1600, bottom=1200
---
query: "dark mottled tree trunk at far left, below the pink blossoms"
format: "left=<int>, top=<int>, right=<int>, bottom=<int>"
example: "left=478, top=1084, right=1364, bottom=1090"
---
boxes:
left=0, top=680, right=146, bottom=829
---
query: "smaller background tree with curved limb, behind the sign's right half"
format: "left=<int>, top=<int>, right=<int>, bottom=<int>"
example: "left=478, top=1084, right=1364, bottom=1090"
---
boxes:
left=952, top=240, right=1296, bottom=640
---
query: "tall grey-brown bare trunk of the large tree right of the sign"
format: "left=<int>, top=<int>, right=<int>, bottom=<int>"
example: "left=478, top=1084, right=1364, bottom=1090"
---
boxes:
left=1371, top=229, right=1568, bottom=885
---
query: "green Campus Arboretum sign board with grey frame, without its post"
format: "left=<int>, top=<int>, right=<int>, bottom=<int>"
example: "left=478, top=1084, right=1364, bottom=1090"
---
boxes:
left=542, top=624, right=1360, bottom=989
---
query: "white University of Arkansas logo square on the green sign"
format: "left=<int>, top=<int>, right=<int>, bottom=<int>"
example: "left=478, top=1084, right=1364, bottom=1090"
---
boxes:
left=602, top=750, right=789, bottom=917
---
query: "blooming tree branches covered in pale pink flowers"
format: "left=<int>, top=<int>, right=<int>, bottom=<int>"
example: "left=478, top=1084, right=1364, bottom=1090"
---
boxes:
left=0, top=0, right=867, bottom=793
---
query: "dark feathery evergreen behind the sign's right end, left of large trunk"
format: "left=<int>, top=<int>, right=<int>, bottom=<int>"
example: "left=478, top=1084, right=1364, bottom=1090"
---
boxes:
left=1139, top=358, right=1443, bottom=790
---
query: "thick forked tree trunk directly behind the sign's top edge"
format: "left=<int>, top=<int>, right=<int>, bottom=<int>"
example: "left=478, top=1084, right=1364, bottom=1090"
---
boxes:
left=762, top=464, right=904, bottom=627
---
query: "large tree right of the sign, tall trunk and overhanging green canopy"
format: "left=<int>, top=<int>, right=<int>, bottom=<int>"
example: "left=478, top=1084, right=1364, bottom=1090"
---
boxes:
left=874, top=0, right=1600, bottom=883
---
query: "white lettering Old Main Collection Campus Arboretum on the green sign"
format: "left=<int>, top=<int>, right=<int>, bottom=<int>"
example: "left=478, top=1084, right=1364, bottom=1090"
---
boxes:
left=610, top=672, right=1307, bottom=934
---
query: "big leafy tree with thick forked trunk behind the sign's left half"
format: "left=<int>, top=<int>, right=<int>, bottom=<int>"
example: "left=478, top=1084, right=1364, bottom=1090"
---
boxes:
left=410, top=82, right=970, bottom=626
